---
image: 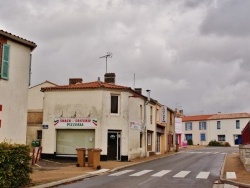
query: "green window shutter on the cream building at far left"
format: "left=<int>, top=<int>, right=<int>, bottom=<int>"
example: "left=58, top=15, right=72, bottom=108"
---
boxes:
left=1, top=44, right=10, bottom=80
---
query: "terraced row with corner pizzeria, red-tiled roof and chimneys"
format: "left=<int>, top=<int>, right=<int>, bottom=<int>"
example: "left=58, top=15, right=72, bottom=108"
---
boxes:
left=41, top=73, right=174, bottom=161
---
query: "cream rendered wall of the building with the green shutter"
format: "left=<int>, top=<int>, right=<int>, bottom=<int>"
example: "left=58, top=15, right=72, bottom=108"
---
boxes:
left=0, top=41, right=30, bottom=144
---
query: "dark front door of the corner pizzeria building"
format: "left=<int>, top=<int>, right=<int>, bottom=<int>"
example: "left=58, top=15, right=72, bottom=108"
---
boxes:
left=107, top=131, right=121, bottom=161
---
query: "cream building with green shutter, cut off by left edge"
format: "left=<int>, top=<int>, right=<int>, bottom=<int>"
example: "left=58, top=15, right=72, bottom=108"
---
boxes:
left=0, top=30, right=36, bottom=144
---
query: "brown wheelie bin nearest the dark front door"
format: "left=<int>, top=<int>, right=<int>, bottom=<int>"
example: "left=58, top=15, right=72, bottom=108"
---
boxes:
left=88, top=148, right=102, bottom=169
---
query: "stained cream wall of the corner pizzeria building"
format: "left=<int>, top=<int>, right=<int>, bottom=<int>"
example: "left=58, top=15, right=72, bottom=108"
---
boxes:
left=42, top=89, right=143, bottom=160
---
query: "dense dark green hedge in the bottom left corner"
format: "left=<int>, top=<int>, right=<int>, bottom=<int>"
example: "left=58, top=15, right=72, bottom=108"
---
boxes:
left=0, top=141, right=32, bottom=188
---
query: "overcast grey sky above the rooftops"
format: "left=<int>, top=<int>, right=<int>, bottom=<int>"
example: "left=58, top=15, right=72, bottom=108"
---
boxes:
left=0, top=0, right=250, bottom=115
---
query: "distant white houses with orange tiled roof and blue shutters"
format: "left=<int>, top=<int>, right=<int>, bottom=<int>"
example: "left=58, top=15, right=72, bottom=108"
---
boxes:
left=182, top=113, right=250, bottom=146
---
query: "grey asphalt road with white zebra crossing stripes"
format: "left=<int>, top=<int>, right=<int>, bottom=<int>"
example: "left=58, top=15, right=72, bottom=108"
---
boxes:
left=60, top=147, right=237, bottom=188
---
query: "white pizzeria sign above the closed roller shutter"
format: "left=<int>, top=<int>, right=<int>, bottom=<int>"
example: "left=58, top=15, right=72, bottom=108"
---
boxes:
left=54, top=118, right=97, bottom=128
